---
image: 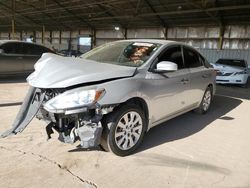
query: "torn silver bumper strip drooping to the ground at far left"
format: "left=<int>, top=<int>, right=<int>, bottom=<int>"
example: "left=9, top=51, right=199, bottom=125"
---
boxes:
left=0, top=87, right=45, bottom=138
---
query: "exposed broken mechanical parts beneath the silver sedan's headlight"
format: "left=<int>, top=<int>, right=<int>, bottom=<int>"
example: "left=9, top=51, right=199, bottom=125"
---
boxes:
left=41, top=99, right=104, bottom=148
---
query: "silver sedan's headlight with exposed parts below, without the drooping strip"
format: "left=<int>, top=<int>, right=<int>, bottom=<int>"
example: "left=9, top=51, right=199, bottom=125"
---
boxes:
left=37, top=88, right=108, bottom=148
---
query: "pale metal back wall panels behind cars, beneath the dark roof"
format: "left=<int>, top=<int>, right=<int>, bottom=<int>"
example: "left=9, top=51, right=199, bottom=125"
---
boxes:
left=0, top=25, right=250, bottom=65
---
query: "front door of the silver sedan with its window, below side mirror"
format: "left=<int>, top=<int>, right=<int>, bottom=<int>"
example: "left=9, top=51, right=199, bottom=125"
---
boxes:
left=144, top=46, right=190, bottom=124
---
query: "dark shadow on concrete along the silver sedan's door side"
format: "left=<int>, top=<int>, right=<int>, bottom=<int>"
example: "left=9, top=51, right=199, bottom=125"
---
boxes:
left=137, top=95, right=242, bottom=152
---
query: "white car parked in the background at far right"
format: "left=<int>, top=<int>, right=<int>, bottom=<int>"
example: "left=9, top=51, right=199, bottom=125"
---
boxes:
left=212, top=59, right=249, bottom=85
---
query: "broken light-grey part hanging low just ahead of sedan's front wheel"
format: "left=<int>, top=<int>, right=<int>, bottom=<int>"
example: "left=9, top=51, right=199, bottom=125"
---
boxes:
left=76, top=122, right=102, bottom=148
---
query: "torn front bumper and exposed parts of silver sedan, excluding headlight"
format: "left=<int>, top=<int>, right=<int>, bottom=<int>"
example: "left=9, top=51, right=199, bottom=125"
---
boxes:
left=0, top=87, right=109, bottom=148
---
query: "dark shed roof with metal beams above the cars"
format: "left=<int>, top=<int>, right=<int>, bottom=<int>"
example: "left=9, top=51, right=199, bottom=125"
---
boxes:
left=0, top=0, right=250, bottom=31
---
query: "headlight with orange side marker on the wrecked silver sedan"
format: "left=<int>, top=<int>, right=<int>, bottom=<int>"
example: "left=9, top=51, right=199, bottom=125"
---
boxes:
left=44, top=89, right=105, bottom=113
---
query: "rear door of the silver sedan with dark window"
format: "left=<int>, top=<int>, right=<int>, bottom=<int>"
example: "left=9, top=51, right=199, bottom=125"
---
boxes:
left=183, top=46, right=213, bottom=105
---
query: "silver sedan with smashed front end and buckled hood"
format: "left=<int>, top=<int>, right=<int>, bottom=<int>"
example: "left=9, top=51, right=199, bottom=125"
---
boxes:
left=1, top=39, right=216, bottom=156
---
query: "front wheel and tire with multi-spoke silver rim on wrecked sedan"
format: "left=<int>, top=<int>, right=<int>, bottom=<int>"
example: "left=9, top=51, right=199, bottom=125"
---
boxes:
left=101, top=104, right=147, bottom=156
